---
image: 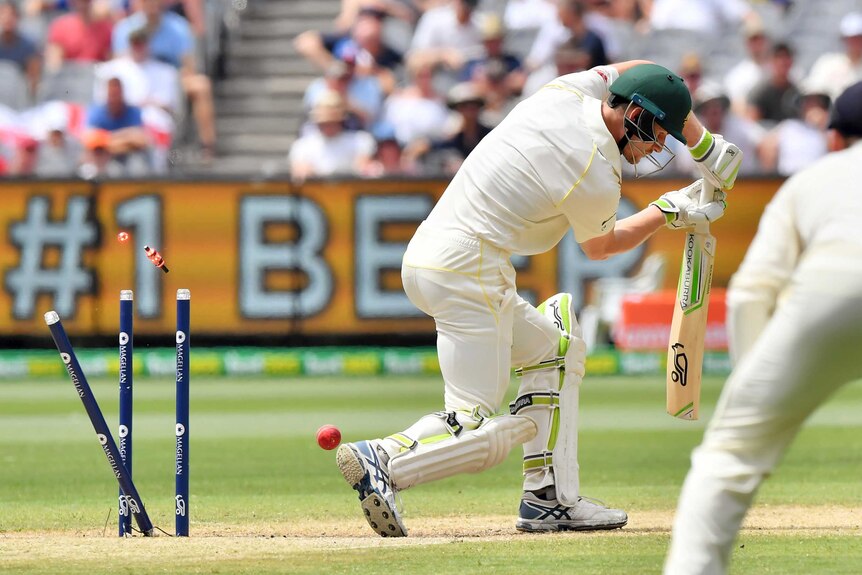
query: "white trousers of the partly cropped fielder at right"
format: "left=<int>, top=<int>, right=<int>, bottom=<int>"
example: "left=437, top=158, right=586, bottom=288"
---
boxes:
left=664, top=272, right=862, bottom=575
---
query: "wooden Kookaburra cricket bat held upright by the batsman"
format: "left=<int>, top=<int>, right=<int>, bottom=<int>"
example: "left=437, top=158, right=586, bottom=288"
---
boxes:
left=667, top=182, right=715, bottom=420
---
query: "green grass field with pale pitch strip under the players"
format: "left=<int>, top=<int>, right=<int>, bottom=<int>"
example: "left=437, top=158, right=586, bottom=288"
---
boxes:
left=0, top=376, right=862, bottom=574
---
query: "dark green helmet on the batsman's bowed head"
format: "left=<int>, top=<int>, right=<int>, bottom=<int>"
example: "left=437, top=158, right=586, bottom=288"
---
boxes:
left=610, top=64, right=691, bottom=144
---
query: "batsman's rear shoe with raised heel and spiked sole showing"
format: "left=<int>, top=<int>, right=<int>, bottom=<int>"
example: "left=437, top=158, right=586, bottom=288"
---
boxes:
left=335, top=440, right=407, bottom=537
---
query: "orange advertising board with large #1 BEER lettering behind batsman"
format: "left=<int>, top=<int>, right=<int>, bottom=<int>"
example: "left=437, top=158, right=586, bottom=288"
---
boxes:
left=0, top=180, right=780, bottom=339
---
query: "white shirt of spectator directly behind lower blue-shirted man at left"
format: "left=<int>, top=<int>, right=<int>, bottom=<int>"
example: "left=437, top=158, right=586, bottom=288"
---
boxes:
left=93, top=56, right=180, bottom=112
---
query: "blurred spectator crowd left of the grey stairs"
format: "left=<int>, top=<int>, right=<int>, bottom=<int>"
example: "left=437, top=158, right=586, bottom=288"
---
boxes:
left=0, top=0, right=216, bottom=178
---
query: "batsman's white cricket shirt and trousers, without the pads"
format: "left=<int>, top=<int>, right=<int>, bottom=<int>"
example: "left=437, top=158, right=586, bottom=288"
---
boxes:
left=402, top=67, right=621, bottom=488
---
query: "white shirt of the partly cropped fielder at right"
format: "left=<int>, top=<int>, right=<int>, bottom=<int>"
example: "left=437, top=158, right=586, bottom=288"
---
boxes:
left=727, top=142, right=862, bottom=361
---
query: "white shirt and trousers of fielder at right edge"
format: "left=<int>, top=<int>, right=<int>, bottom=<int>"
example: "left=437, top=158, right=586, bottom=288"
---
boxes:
left=665, top=142, right=862, bottom=575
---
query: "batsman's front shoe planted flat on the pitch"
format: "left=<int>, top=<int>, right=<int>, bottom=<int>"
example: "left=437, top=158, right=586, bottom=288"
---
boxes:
left=515, top=491, right=629, bottom=531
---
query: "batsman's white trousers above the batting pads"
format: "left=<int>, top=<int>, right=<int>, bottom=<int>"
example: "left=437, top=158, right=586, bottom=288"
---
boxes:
left=401, top=224, right=564, bottom=486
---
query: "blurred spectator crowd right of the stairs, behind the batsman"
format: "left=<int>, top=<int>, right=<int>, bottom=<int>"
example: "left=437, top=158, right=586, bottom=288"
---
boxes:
left=289, top=0, right=862, bottom=181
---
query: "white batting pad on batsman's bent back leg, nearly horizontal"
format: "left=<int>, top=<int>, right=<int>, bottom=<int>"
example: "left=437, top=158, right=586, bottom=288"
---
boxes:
left=389, top=415, right=536, bottom=490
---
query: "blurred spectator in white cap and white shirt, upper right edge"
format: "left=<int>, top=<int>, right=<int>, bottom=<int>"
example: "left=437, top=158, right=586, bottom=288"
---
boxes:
left=807, top=12, right=862, bottom=100
